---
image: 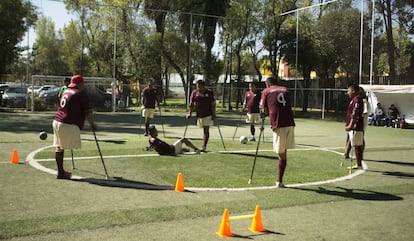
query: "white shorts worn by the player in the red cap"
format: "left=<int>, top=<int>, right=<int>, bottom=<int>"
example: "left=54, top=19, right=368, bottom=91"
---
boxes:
left=52, top=120, right=81, bottom=150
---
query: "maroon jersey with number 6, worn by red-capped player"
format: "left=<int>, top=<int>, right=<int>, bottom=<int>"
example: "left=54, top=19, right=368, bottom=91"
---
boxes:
left=55, top=88, right=91, bottom=130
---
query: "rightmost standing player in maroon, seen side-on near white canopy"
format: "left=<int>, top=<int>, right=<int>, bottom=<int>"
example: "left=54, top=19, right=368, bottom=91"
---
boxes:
left=345, top=84, right=364, bottom=169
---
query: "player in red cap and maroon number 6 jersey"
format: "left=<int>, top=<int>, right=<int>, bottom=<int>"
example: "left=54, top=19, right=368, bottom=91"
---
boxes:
left=52, top=75, right=96, bottom=179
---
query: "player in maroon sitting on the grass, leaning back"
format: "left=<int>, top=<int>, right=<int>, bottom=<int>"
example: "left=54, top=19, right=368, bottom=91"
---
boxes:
left=148, top=125, right=200, bottom=155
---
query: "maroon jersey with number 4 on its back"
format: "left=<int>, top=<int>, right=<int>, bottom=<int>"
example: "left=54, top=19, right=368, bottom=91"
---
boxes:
left=261, top=85, right=295, bottom=129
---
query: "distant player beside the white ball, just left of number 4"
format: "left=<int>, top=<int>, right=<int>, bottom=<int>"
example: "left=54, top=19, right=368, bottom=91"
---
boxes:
left=243, top=83, right=261, bottom=141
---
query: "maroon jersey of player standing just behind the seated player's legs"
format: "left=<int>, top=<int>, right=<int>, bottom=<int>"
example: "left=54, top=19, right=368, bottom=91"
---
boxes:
left=190, top=89, right=216, bottom=118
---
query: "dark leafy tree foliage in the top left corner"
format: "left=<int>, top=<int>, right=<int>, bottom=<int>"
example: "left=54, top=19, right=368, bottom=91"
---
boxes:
left=0, top=0, right=37, bottom=81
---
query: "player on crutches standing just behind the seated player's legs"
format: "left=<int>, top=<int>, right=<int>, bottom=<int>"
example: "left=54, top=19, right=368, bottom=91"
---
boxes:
left=187, top=80, right=216, bottom=151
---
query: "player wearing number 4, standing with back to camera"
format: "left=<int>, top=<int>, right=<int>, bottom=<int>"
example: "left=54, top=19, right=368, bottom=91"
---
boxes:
left=260, top=77, right=295, bottom=187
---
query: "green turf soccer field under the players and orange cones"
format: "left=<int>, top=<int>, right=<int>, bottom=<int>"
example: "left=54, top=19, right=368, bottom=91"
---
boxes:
left=0, top=112, right=414, bottom=240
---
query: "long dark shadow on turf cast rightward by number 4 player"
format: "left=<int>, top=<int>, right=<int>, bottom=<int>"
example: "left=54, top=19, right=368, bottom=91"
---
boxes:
left=292, top=187, right=403, bottom=201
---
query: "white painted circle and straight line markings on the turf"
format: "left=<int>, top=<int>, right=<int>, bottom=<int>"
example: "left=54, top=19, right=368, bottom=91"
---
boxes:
left=26, top=146, right=368, bottom=192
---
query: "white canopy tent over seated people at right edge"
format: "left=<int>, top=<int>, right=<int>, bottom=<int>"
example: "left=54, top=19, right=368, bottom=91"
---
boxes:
left=361, top=85, right=414, bottom=124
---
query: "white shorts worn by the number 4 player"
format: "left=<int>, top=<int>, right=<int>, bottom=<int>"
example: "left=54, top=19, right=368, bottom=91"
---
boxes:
left=273, top=126, right=295, bottom=154
